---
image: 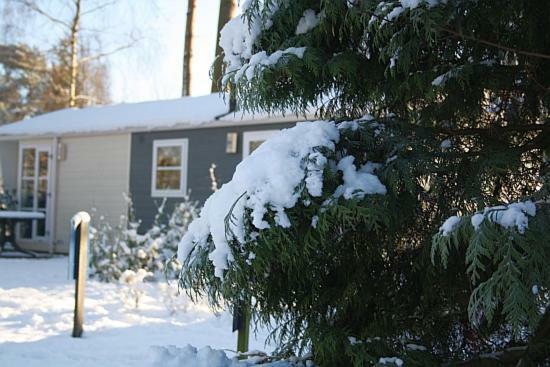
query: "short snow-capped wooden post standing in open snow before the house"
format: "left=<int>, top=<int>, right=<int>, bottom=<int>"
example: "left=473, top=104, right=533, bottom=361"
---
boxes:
left=69, top=212, right=90, bottom=338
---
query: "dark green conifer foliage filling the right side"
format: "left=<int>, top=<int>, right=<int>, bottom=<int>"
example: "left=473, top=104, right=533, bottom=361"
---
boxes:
left=181, top=0, right=550, bottom=366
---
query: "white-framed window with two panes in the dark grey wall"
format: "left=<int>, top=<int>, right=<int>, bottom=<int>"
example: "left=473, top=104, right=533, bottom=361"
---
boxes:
left=151, top=139, right=188, bottom=197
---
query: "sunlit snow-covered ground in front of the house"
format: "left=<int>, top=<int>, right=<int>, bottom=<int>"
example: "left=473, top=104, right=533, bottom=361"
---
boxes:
left=0, top=257, right=272, bottom=367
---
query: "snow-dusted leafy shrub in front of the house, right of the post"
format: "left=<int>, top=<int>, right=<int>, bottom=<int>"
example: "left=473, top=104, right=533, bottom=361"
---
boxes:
left=90, top=196, right=199, bottom=282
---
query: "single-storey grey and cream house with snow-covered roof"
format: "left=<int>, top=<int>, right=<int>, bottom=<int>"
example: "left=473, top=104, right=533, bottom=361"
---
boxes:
left=0, top=94, right=303, bottom=253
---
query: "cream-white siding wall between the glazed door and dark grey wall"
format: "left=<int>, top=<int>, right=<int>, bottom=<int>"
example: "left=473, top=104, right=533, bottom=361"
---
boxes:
left=55, top=134, right=131, bottom=252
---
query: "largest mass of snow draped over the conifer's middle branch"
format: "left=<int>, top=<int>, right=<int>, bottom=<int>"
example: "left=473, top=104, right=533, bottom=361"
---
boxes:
left=178, top=121, right=386, bottom=278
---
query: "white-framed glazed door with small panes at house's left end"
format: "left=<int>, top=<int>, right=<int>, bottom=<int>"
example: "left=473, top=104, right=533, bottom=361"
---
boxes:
left=17, top=144, right=52, bottom=241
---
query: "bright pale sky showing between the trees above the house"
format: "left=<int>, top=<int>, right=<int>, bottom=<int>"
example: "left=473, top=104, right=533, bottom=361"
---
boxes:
left=0, top=0, right=225, bottom=103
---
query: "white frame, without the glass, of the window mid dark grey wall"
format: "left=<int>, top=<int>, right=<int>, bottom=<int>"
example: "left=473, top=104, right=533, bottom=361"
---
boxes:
left=151, top=139, right=189, bottom=198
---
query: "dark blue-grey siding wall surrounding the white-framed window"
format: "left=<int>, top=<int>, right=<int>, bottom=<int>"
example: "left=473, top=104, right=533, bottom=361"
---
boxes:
left=130, top=122, right=295, bottom=230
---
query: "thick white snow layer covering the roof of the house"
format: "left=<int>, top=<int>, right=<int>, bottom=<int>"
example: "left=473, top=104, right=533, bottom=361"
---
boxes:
left=0, top=94, right=233, bottom=137
